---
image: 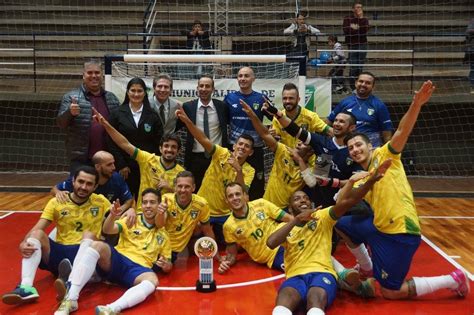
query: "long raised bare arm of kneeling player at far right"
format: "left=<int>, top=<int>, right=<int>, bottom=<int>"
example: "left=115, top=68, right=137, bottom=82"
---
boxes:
left=390, top=80, right=435, bottom=152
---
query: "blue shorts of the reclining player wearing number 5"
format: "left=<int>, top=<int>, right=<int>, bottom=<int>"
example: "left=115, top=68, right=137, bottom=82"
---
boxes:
left=280, top=272, right=337, bottom=308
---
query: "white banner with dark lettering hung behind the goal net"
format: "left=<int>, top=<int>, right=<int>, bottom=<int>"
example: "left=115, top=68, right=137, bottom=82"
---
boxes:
left=112, top=77, right=331, bottom=117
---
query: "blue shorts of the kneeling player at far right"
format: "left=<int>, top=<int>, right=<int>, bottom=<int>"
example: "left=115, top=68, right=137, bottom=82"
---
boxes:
left=336, top=216, right=421, bottom=290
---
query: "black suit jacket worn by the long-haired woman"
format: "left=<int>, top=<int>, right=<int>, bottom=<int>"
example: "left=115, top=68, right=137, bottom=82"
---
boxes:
left=109, top=104, right=163, bottom=170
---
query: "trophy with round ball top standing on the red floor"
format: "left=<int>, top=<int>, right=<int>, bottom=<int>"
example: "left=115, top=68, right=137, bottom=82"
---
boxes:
left=194, top=236, right=217, bottom=293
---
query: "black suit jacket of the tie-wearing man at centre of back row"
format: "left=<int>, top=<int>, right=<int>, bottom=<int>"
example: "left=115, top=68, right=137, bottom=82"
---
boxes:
left=176, top=98, right=229, bottom=169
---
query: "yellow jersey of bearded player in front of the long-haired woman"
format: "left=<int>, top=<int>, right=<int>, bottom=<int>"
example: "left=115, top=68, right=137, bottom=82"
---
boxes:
left=132, top=148, right=184, bottom=212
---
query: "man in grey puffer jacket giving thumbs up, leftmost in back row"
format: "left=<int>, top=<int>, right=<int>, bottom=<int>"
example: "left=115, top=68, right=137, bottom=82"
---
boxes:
left=56, top=60, right=120, bottom=174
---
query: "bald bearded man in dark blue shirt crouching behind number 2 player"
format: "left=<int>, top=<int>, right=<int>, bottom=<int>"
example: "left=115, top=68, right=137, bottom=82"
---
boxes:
left=51, top=151, right=133, bottom=212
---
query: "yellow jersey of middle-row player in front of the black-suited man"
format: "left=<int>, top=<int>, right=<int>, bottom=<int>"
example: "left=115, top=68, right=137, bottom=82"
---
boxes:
left=197, top=144, right=255, bottom=217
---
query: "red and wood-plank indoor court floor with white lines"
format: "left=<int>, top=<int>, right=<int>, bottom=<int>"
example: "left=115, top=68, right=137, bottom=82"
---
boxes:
left=0, top=177, right=474, bottom=315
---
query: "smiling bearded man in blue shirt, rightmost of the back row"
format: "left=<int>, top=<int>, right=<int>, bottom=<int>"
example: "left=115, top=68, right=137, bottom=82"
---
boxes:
left=326, top=71, right=393, bottom=148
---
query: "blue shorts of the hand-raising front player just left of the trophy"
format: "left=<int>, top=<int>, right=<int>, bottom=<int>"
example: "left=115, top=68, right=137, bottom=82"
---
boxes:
left=97, top=245, right=153, bottom=288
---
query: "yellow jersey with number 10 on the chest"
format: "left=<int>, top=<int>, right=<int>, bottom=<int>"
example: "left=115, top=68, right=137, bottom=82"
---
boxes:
left=223, top=199, right=285, bottom=268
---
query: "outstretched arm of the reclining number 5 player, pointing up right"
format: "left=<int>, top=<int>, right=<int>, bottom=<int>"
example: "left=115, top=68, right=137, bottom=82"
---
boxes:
left=332, top=159, right=392, bottom=218
